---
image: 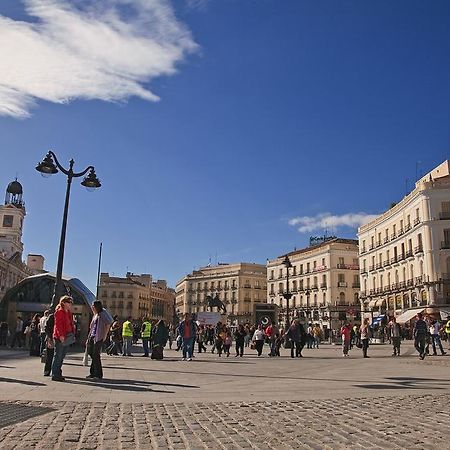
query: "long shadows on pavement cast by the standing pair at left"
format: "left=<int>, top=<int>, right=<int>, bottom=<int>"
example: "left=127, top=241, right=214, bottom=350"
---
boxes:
left=66, top=377, right=200, bottom=394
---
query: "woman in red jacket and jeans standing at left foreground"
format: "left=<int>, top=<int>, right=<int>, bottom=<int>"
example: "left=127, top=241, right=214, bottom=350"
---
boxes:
left=52, top=295, right=75, bottom=381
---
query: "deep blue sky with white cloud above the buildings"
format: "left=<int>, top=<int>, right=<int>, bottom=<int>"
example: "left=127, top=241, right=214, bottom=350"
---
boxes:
left=0, top=0, right=450, bottom=289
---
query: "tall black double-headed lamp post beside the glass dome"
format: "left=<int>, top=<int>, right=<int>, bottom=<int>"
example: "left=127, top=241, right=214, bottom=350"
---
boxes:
left=36, top=151, right=101, bottom=309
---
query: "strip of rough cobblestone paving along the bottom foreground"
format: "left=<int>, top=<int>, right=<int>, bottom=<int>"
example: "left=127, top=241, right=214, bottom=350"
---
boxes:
left=0, top=394, right=450, bottom=450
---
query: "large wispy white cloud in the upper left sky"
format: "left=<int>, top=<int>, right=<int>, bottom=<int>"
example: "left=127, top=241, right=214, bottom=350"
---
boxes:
left=0, top=0, right=196, bottom=118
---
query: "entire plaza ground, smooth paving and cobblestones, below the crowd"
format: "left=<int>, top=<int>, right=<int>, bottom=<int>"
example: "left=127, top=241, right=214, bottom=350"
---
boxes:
left=0, top=343, right=450, bottom=450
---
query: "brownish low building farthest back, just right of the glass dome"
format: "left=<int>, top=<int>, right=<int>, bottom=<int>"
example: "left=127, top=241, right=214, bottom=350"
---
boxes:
left=98, top=272, right=175, bottom=324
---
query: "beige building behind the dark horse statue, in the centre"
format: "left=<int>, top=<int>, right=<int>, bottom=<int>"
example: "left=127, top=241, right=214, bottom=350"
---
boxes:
left=176, top=263, right=267, bottom=324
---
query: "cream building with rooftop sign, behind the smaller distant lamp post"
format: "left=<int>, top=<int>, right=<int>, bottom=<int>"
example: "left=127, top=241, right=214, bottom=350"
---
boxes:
left=267, top=238, right=360, bottom=329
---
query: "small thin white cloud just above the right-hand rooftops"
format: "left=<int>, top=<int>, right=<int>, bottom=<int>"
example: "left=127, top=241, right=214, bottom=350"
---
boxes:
left=289, top=212, right=378, bottom=233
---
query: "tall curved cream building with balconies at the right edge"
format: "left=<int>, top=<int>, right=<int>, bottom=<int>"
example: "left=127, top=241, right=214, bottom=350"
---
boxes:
left=358, top=161, right=450, bottom=315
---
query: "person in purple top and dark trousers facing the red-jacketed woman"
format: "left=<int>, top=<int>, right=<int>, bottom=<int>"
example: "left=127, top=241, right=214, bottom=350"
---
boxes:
left=86, top=300, right=113, bottom=380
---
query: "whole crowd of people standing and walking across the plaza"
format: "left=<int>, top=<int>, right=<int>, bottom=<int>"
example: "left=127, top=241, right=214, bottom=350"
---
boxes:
left=0, top=295, right=450, bottom=381
